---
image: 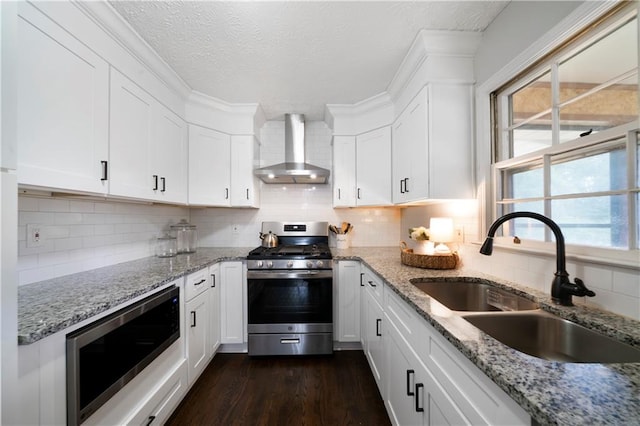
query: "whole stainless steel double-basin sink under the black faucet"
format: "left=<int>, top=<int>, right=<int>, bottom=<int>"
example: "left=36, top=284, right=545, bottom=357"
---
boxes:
left=411, top=279, right=640, bottom=363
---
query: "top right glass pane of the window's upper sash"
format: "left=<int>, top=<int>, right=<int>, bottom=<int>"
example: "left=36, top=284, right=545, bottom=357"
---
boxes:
left=558, top=18, right=638, bottom=104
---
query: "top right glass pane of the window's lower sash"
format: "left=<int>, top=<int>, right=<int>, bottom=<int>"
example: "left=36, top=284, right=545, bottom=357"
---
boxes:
left=551, top=145, right=627, bottom=196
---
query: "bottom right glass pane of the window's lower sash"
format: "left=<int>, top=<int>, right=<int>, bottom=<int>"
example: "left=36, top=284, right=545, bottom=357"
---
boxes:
left=551, top=195, right=629, bottom=248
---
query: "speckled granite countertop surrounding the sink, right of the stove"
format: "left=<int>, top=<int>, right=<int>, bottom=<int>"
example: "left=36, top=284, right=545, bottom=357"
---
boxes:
left=334, top=247, right=640, bottom=425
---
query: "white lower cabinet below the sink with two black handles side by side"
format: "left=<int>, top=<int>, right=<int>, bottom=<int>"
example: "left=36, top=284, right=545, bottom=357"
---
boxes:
left=383, top=282, right=531, bottom=425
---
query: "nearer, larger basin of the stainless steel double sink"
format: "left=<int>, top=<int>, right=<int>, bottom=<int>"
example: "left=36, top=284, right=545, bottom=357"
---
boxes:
left=464, top=311, right=640, bottom=363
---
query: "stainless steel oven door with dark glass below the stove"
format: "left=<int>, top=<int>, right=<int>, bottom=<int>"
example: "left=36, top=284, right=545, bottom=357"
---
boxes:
left=247, top=270, right=333, bottom=333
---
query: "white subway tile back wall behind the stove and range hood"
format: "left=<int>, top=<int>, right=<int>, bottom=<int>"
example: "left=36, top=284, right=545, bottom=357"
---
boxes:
left=191, top=121, right=400, bottom=247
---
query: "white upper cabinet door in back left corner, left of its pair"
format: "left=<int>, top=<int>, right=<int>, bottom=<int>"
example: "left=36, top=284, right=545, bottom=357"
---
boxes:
left=189, top=124, right=231, bottom=206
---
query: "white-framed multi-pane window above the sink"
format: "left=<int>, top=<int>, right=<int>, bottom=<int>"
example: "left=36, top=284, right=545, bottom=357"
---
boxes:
left=491, top=2, right=640, bottom=255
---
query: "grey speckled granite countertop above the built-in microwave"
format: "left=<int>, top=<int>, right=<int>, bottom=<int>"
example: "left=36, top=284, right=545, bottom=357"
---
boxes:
left=18, top=248, right=251, bottom=345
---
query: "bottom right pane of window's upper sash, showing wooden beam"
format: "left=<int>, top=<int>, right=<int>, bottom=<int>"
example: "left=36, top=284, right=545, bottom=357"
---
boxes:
left=560, top=74, right=638, bottom=142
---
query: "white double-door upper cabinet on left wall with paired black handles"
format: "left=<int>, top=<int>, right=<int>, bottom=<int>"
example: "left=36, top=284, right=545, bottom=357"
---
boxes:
left=109, top=69, right=187, bottom=203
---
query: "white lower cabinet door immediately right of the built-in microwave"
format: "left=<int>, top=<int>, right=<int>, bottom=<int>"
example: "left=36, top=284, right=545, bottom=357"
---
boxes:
left=185, top=291, right=210, bottom=384
